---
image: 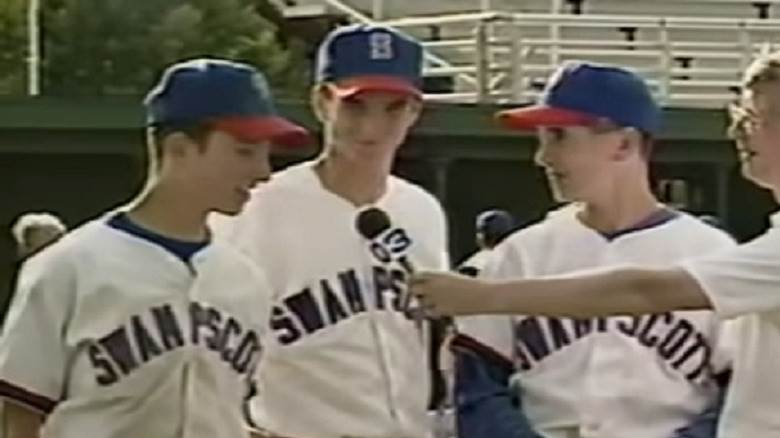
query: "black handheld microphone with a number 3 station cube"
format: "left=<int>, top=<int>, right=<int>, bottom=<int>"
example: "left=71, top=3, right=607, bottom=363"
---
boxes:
left=355, top=207, right=416, bottom=312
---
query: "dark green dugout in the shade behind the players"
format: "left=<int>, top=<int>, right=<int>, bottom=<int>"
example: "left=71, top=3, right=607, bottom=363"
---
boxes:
left=0, top=98, right=773, bottom=312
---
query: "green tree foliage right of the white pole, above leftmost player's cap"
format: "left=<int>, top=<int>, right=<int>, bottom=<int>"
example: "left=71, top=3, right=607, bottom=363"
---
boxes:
left=39, top=0, right=308, bottom=95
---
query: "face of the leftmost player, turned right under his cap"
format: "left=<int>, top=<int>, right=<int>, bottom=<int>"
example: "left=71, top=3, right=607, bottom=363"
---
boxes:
left=163, top=131, right=271, bottom=215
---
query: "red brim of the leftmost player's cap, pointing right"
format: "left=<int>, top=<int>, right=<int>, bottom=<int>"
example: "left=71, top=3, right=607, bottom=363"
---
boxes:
left=213, top=116, right=311, bottom=147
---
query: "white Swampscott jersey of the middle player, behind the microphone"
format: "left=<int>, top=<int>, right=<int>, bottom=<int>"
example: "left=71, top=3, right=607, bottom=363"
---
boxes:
left=215, top=162, right=447, bottom=438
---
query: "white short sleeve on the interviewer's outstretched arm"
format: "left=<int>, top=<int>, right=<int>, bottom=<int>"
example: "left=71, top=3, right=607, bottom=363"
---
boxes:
left=682, top=228, right=780, bottom=318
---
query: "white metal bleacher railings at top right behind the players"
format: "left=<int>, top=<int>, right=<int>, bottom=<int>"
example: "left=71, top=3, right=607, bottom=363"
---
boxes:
left=290, top=0, right=780, bottom=107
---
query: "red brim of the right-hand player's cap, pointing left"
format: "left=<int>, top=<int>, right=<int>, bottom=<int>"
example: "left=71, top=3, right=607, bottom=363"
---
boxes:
left=496, top=105, right=598, bottom=131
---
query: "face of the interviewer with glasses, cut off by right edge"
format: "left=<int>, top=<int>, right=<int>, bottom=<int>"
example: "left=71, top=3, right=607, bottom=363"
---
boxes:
left=729, top=84, right=780, bottom=188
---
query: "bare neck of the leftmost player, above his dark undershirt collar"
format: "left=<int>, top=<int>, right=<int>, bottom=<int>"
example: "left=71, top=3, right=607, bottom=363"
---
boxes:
left=127, top=183, right=209, bottom=242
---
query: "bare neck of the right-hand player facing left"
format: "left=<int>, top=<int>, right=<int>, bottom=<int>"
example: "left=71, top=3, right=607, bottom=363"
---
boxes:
left=579, top=179, right=658, bottom=233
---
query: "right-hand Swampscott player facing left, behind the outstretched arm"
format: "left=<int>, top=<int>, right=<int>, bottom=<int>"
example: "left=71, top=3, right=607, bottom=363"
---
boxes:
left=444, top=62, right=733, bottom=438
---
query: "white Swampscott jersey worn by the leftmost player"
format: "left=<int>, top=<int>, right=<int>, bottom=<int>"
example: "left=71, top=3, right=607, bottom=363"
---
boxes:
left=0, top=213, right=269, bottom=438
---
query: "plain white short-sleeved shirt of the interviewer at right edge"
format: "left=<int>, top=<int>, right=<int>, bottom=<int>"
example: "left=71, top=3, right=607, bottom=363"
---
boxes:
left=683, top=213, right=780, bottom=438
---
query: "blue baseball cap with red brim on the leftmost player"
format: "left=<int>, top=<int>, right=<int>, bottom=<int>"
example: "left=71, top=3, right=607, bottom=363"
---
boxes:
left=144, top=59, right=309, bottom=146
